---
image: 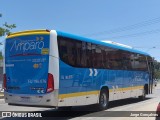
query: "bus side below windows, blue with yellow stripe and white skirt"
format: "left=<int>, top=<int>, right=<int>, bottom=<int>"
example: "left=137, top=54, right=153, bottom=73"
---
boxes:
left=59, top=61, right=149, bottom=106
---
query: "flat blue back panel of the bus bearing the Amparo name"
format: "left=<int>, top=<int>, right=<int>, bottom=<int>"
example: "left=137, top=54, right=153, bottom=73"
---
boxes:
left=5, top=35, right=49, bottom=94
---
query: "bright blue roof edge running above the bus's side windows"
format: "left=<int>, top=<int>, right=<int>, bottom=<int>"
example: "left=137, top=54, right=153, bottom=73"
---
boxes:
left=56, top=31, right=150, bottom=56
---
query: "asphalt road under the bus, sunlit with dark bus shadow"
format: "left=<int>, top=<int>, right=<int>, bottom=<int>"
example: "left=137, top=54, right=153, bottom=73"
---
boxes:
left=0, top=84, right=160, bottom=120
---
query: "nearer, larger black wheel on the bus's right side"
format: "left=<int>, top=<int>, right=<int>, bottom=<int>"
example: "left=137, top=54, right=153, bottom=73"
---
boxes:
left=98, top=89, right=109, bottom=110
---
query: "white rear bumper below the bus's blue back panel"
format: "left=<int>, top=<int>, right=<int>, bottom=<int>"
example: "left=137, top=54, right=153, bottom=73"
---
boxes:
left=4, top=90, right=58, bottom=107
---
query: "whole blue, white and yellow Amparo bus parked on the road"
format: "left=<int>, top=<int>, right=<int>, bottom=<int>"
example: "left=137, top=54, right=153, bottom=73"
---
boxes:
left=3, top=30, right=153, bottom=110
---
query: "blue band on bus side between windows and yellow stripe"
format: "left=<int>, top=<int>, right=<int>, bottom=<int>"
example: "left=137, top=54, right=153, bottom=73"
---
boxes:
left=59, top=60, right=149, bottom=94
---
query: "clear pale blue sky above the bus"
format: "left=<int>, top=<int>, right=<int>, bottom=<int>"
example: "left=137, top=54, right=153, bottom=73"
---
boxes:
left=0, top=0, right=160, bottom=61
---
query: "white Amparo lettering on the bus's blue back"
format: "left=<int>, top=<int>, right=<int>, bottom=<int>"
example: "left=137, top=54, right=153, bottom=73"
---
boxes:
left=10, top=40, right=44, bottom=52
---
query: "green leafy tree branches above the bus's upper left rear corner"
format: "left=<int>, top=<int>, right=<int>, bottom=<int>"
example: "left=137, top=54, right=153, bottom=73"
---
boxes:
left=0, top=13, right=16, bottom=37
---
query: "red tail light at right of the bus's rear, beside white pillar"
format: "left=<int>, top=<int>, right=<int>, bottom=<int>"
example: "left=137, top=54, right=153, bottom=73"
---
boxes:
left=47, top=73, right=54, bottom=93
